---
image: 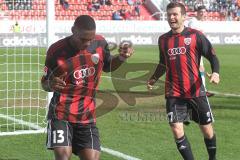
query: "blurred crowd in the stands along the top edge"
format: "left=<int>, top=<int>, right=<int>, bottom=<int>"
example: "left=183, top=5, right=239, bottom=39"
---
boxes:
left=0, top=0, right=240, bottom=21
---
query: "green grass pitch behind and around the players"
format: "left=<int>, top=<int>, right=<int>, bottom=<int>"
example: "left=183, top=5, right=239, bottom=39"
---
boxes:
left=0, top=45, right=240, bottom=160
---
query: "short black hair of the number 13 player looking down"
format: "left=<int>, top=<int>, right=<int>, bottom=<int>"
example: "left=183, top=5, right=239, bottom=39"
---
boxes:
left=74, top=15, right=96, bottom=30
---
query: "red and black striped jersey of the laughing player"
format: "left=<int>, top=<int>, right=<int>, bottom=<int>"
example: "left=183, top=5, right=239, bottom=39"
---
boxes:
left=158, top=27, right=219, bottom=98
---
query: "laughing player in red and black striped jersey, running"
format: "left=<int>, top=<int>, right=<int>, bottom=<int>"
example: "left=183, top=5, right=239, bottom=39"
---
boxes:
left=147, top=2, right=220, bottom=160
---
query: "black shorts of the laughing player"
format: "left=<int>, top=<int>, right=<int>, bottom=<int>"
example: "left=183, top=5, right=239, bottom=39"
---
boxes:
left=166, top=96, right=214, bottom=125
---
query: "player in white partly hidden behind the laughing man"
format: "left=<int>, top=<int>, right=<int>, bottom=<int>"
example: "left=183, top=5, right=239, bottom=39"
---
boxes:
left=188, top=6, right=214, bottom=97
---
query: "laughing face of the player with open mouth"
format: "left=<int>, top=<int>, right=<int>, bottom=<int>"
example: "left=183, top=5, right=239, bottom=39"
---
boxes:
left=167, top=7, right=185, bottom=33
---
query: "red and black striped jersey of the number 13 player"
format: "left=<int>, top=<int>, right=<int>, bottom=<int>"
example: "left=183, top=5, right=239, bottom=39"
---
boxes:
left=45, top=35, right=111, bottom=125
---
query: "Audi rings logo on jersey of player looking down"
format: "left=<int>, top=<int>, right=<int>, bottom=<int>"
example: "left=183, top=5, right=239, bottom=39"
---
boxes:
left=73, top=67, right=95, bottom=80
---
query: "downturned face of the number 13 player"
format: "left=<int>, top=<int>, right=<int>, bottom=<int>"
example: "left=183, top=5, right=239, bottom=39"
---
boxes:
left=72, top=29, right=96, bottom=50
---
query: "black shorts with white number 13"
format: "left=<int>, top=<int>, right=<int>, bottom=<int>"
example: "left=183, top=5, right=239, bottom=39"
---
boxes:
left=46, top=119, right=100, bottom=155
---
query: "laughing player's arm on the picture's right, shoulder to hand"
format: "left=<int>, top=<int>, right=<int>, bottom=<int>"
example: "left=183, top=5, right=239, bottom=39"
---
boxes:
left=198, top=34, right=220, bottom=84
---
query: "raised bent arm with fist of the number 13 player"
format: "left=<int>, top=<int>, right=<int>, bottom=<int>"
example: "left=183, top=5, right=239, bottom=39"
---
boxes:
left=103, top=42, right=134, bottom=72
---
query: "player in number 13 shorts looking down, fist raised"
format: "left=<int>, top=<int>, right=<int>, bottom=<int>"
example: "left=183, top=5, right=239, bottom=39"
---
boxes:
left=41, top=15, right=133, bottom=160
